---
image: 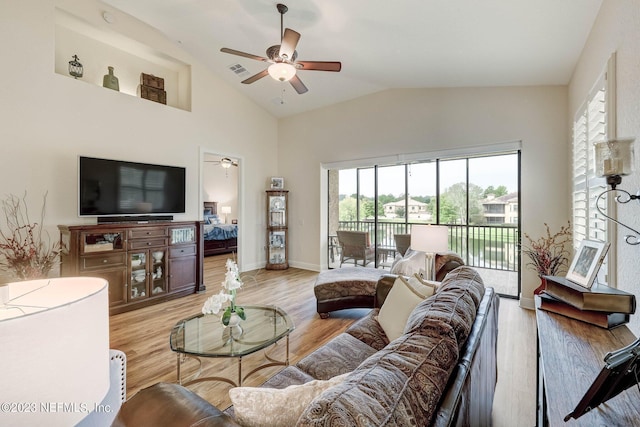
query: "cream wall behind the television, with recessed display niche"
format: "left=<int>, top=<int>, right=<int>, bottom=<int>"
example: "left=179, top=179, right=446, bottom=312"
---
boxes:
left=0, top=0, right=277, bottom=269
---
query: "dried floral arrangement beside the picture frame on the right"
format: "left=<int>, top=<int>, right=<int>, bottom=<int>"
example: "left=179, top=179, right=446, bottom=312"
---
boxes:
left=522, top=222, right=572, bottom=277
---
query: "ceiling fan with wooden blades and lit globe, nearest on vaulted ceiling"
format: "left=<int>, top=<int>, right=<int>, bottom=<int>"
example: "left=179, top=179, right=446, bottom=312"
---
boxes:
left=220, top=3, right=342, bottom=94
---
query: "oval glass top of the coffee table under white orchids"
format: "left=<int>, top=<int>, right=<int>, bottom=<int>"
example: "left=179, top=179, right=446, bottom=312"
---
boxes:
left=169, top=305, right=295, bottom=357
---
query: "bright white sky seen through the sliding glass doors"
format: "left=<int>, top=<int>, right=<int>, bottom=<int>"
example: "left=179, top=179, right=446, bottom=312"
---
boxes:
left=339, top=154, right=518, bottom=197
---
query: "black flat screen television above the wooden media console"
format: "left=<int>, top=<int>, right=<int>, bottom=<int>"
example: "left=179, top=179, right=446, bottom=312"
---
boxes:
left=78, top=156, right=186, bottom=217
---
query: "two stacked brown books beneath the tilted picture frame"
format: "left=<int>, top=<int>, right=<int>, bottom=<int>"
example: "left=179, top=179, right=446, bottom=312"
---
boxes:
left=536, top=276, right=636, bottom=329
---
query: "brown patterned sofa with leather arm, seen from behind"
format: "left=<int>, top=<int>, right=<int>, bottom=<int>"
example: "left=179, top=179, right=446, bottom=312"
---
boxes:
left=114, top=266, right=499, bottom=427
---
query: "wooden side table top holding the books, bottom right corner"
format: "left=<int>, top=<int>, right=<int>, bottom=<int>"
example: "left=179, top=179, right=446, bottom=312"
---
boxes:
left=536, top=300, right=640, bottom=427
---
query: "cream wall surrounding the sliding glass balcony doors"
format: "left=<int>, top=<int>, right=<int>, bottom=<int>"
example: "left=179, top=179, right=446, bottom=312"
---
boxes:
left=278, top=87, right=570, bottom=307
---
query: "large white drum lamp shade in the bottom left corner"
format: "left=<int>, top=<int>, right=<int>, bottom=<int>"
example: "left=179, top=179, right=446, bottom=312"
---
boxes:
left=0, top=277, right=109, bottom=426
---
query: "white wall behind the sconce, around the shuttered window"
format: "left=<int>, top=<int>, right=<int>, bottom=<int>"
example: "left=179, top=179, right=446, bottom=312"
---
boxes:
left=568, top=0, right=640, bottom=335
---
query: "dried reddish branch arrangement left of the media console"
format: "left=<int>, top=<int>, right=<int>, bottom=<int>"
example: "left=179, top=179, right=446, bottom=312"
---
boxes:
left=0, top=193, right=63, bottom=280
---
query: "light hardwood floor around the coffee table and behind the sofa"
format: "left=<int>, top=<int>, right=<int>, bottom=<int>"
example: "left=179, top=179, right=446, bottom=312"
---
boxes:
left=110, top=255, right=536, bottom=427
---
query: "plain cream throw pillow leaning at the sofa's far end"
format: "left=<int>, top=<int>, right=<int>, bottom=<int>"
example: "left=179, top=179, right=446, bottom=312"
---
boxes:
left=378, top=277, right=425, bottom=341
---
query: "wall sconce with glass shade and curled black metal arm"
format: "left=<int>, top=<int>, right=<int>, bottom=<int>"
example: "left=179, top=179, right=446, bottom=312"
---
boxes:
left=594, top=139, right=640, bottom=245
